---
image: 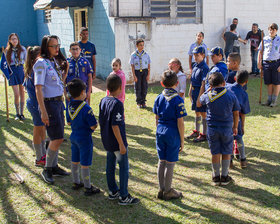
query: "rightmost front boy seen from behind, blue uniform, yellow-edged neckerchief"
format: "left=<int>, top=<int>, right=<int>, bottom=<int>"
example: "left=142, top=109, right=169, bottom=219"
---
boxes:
left=199, top=72, right=240, bottom=185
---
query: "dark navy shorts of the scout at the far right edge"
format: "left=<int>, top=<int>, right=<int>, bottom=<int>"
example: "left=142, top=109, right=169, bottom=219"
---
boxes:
left=263, top=60, right=280, bottom=85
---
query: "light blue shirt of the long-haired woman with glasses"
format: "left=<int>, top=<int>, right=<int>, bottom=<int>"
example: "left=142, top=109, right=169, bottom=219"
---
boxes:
left=33, top=58, right=64, bottom=98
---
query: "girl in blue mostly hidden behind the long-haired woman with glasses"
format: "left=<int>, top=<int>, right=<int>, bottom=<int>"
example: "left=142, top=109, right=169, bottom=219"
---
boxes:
left=24, top=46, right=46, bottom=167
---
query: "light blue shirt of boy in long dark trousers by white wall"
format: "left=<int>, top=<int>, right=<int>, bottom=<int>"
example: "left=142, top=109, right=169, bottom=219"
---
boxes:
left=129, top=50, right=151, bottom=70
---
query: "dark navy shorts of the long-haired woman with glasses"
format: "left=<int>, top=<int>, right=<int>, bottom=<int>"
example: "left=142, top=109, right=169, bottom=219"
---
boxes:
left=44, top=101, right=64, bottom=140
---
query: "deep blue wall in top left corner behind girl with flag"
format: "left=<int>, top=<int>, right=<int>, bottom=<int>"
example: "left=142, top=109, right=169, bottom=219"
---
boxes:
left=0, top=0, right=38, bottom=47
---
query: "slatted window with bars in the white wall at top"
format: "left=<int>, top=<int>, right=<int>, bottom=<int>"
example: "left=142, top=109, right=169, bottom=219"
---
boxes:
left=150, top=0, right=202, bottom=23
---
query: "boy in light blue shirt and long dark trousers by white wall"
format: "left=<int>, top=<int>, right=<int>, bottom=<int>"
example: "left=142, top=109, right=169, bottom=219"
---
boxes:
left=130, top=39, right=151, bottom=108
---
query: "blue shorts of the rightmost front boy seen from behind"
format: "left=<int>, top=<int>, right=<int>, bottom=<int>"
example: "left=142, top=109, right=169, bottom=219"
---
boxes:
left=207, top=126, right=233, bottom=155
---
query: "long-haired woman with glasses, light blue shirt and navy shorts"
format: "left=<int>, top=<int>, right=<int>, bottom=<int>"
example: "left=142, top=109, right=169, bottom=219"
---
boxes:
left=33, top=35, right=69, bottom=184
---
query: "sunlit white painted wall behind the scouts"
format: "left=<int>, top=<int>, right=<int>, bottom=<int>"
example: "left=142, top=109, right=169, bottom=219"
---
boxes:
left=115, top=0, right=280, bottom=81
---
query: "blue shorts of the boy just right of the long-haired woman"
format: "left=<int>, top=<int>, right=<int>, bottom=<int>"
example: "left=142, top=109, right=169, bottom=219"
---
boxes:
left=70, top=135, right=93, bottom=166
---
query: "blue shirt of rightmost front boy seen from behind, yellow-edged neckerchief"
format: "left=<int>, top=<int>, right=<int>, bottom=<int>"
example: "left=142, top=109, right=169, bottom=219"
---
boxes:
left=200, top=87, right=240, bottom=127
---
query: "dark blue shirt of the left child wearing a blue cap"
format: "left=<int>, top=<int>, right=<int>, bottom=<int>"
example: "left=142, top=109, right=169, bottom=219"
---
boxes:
left=191, top=61, right=209, bottom=87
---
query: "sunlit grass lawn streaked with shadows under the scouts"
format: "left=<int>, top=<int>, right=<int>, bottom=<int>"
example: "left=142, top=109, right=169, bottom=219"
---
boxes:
left=0, top=78, right=280, bottom=224
